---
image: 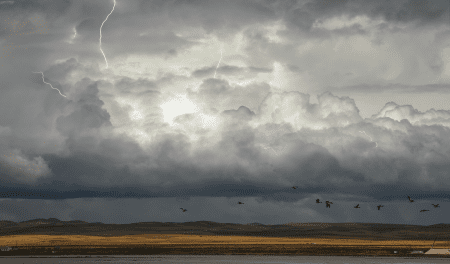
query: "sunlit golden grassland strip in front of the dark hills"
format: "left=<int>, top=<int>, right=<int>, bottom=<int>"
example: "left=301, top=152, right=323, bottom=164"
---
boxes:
left=0, top=234, right=450, bottom=248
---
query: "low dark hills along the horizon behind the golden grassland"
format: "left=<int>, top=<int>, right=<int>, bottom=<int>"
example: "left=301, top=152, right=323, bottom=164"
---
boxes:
left=0, top=218, right=450, bottom=240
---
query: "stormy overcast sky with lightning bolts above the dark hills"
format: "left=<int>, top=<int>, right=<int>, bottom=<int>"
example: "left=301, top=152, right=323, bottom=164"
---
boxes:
left=0, top=0, right=450, bottom=225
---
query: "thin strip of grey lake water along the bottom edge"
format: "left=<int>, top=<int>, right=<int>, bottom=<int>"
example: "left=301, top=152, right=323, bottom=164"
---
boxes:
left=0, top=255, right=450, bottom=264
